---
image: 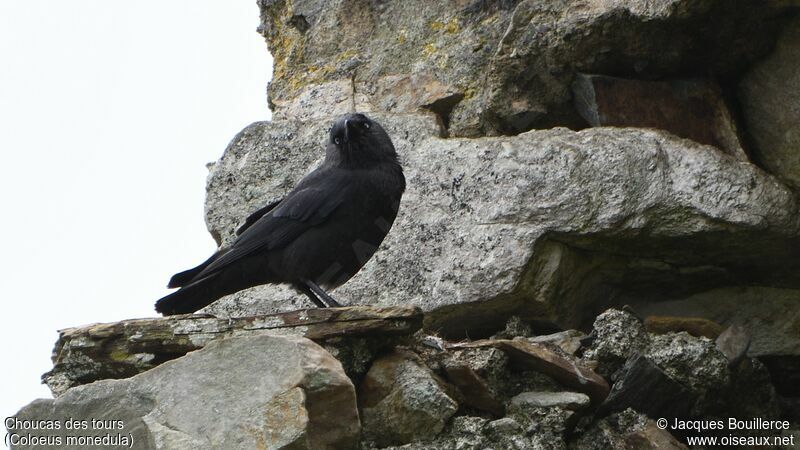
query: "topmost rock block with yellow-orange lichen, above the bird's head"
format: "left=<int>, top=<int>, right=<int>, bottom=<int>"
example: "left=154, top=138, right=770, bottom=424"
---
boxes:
left=259, top=0, right=784, bottom=136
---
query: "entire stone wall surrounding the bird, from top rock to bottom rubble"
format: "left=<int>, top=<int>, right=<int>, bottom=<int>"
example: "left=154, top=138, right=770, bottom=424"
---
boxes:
left=7, top=0, right=800, bottom=449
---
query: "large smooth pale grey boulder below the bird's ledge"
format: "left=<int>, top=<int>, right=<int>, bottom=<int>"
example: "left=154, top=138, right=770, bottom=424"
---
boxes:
left=17, top=335, right=360, bottom=450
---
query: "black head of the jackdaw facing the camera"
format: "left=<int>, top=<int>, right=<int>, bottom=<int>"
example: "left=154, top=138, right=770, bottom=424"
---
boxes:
left=327, top=113, right=397, bottom=165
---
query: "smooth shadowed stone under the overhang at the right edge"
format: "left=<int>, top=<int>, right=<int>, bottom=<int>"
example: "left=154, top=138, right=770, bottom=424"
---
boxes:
left=632, top=286, right=800, bottom=356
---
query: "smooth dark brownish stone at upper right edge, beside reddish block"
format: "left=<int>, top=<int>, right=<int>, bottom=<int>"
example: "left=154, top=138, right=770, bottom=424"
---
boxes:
left=739, top=14, right=800, bottom=190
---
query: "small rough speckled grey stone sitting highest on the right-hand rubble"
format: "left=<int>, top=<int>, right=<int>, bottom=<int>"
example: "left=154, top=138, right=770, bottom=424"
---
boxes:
left=583, top=309, right=650, bottom=377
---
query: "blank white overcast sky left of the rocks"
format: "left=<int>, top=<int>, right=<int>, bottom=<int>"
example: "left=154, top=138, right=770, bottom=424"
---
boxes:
left=0, top=0, right=272, bottom=428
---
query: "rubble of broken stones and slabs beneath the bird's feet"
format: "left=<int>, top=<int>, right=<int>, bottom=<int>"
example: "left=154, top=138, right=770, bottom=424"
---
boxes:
left=14, top=307, right=800, bottom=450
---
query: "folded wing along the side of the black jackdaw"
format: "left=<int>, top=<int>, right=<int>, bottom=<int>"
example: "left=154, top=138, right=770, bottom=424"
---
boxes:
left=189, top=172, right=352, bottom=280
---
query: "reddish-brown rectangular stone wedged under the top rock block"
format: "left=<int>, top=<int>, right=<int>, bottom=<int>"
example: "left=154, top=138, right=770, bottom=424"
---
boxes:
left=572, top=74, right=748, bottom=161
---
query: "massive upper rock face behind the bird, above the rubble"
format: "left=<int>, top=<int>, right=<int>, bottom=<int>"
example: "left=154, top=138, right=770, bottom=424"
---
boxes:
left=192, top=0, right=800, bottom=372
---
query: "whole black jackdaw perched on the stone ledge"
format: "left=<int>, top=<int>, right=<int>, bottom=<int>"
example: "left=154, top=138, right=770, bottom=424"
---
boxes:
left=156, top=113, right=405, bottom=315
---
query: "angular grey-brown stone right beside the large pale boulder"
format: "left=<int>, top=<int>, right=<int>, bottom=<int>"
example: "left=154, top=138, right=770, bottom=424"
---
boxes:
left=358, top=351, right=458, bottom=446
